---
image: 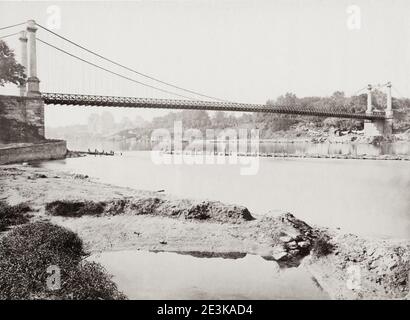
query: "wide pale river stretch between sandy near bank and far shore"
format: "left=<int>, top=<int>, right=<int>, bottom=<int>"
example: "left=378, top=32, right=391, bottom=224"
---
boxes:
left=42, top=151, right=410, bottom=238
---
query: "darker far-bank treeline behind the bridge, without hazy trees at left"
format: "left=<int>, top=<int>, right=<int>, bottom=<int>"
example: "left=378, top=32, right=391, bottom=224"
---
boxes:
left=117, top=90, right=410, bottom=139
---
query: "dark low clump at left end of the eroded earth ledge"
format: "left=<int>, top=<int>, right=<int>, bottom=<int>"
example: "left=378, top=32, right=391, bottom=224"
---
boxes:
left=46, top=200, right=105, bottom=217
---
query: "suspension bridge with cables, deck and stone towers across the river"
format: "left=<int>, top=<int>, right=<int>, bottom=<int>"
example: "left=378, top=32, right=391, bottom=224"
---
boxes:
left=0, top=20, right=393, bottom=136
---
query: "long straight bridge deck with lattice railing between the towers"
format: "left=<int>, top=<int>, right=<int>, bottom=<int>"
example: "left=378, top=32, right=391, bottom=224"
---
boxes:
left=41, top=93, right=386, bottom=120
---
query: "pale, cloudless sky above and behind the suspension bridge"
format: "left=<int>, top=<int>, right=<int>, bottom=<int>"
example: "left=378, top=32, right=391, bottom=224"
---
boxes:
left=0, top=0, right=410, bottom=126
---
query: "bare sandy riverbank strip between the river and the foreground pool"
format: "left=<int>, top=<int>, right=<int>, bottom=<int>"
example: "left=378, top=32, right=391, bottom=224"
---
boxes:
left=0, top=165, right=410, bottom=299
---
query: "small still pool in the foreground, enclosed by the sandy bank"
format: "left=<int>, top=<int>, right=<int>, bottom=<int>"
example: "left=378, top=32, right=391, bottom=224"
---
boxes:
left=88, top=251, right=328, bottom=299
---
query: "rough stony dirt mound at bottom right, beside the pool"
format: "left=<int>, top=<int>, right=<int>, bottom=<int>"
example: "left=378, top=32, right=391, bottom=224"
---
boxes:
left=304, top=234, right=410, bottom=299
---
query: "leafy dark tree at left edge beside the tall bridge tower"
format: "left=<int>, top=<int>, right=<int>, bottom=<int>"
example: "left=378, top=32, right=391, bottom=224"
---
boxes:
left=0, top=40, right=26, bottom=87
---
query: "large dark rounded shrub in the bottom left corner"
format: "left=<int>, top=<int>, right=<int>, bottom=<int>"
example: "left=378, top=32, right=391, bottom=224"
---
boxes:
left=0, top=222, right=123, bottom=299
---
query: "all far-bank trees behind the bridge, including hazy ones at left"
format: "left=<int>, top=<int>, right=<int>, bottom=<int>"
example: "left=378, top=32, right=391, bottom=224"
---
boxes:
left=48, top=90, right=410, bottom=150
